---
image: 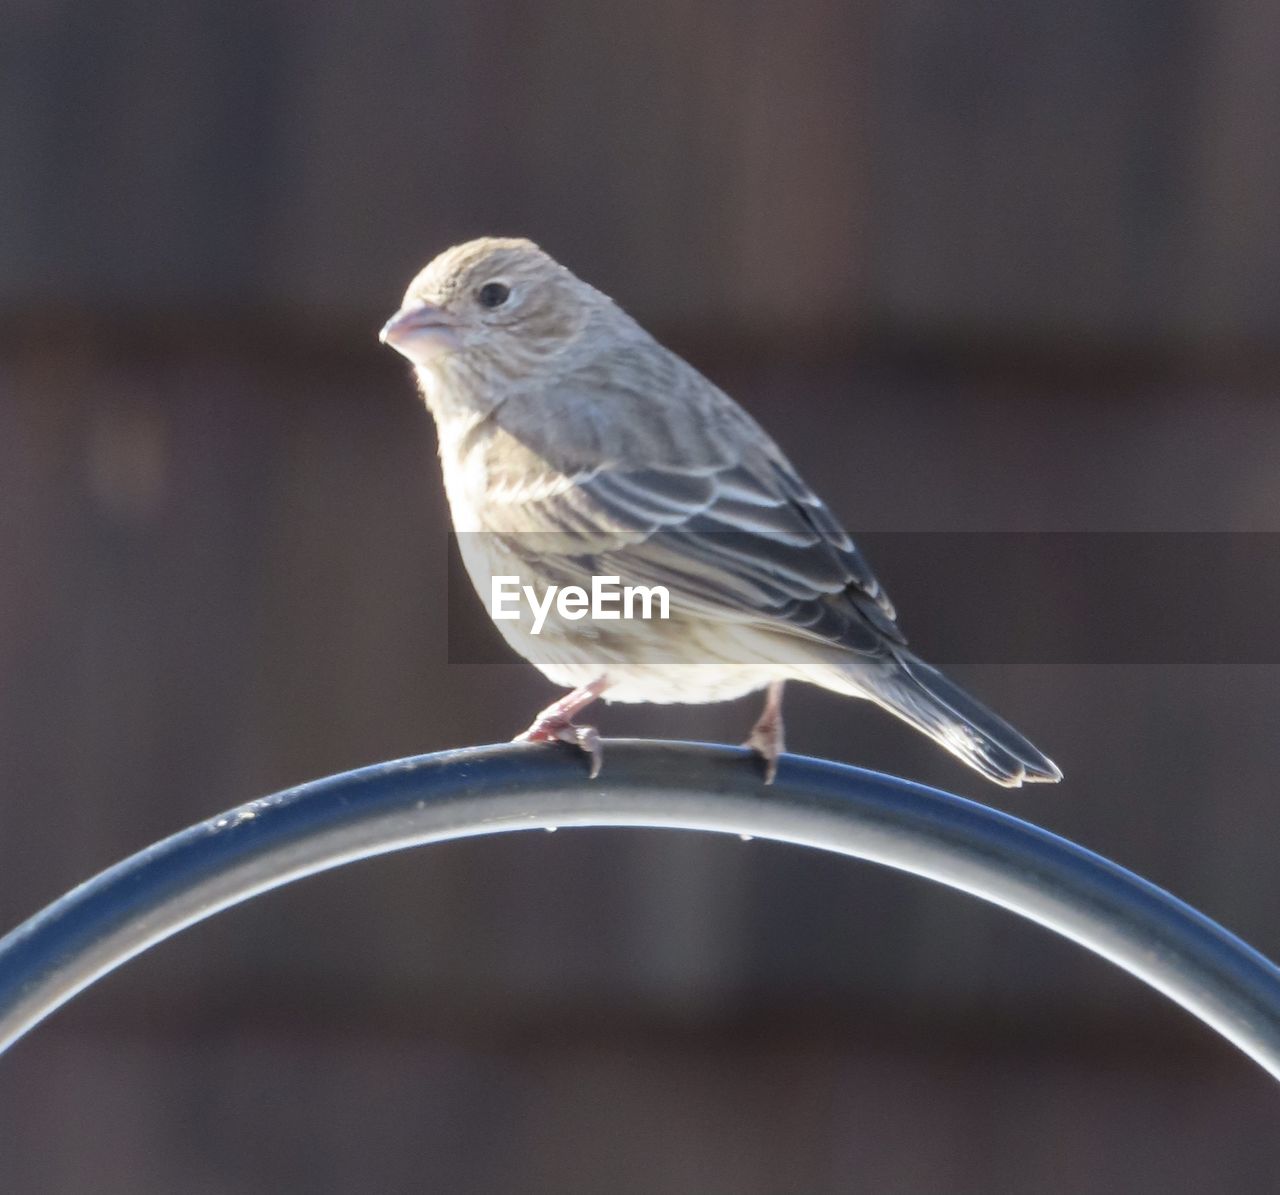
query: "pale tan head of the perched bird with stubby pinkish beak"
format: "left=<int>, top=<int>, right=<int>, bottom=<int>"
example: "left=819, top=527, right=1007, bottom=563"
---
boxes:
left=380, top=237, right=608, bottom=388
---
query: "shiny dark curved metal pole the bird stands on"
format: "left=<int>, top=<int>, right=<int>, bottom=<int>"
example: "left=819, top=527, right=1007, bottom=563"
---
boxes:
left=0, top=740, right=1280, bottom=1079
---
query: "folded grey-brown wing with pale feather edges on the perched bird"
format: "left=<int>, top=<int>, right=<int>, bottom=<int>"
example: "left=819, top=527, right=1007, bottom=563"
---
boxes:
left=490, top=345, right=906, bottom=653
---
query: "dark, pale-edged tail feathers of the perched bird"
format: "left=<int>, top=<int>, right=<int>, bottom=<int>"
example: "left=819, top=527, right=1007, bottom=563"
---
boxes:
left=856, top=647, right=1062, bottom=788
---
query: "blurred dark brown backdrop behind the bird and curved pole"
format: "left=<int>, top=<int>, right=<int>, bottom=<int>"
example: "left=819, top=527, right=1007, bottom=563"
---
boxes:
left=0, top=0, right=1280, bottom=1195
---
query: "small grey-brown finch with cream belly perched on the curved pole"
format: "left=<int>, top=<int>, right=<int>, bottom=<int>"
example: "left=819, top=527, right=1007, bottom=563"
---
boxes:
left=380, top=237, right=1062, bottom=787
